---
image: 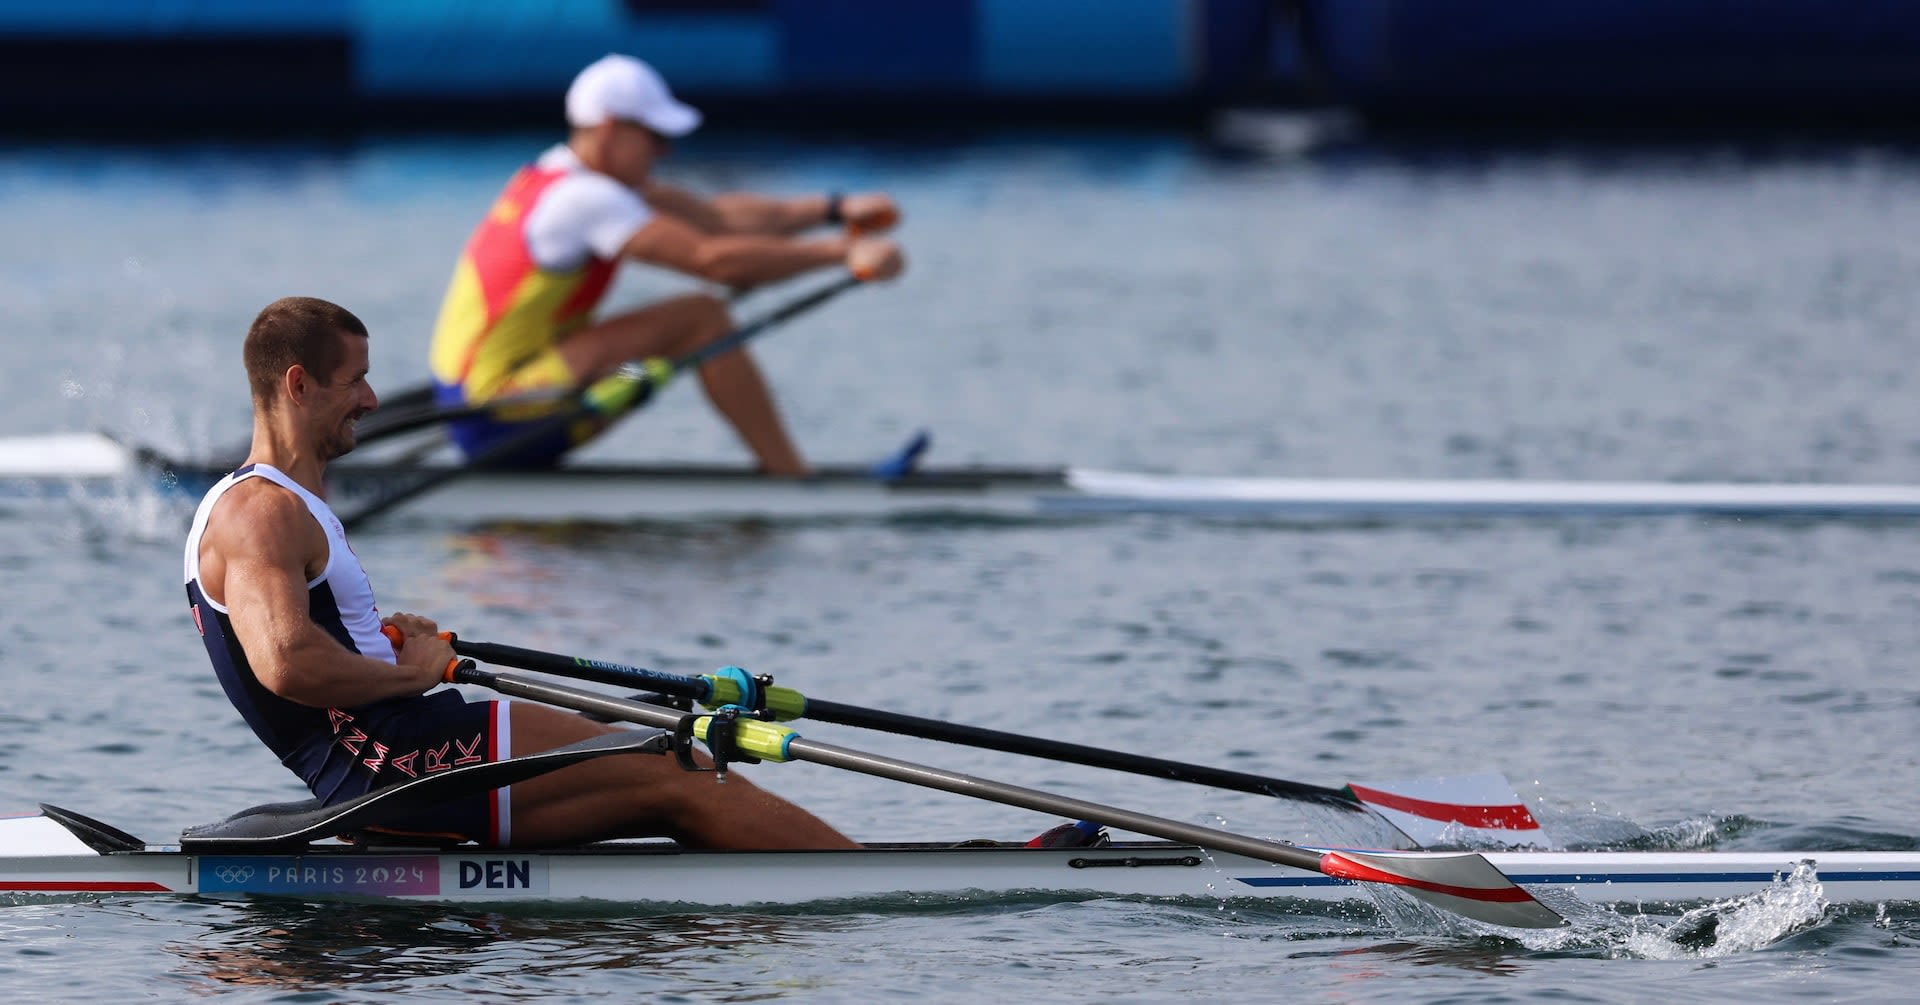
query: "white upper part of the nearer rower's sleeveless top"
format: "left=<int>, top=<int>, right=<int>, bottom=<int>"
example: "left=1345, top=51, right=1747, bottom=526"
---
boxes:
left=186, top=463, right=394, bottom=676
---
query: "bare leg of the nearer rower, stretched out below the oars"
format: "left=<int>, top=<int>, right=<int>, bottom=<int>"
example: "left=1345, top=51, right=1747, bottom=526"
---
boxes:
left=509, top=701, right=858, bottom=849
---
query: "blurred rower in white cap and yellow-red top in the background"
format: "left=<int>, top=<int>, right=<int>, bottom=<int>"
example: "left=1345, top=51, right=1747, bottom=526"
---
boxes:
left=430, top=56, right=904, bottom=477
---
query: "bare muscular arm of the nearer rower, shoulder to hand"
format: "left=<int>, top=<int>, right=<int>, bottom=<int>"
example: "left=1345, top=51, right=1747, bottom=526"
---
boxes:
left=202, top=480, right=453, bottom=707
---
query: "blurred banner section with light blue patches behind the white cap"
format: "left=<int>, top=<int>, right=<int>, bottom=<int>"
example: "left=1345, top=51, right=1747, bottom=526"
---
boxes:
left=0, top=0, right=1236, bottom=125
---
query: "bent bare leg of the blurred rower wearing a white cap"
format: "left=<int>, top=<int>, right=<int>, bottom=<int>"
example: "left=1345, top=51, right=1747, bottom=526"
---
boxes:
left=559, top=294, right=806, bottom=477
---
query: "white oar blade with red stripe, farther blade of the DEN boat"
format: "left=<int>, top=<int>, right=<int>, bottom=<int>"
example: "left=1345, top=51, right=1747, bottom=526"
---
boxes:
left=1346, top=771, right=1555, bottom=847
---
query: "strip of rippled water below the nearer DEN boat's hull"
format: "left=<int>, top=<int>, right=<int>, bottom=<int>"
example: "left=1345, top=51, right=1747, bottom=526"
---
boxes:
left=0, top=884, right=1916, bottom=1001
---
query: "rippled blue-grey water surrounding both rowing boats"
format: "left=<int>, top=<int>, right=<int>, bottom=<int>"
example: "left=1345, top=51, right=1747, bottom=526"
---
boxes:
left=0, top=123, right=1920, bottom=1003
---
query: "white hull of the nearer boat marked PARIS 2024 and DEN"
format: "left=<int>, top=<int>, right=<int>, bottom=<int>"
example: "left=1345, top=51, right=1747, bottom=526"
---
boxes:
left=0, top=809, right=1920, bottom=907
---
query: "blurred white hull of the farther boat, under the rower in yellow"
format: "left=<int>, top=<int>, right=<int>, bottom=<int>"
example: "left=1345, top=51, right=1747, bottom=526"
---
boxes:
left=11, top=432, right=1920, bottom=523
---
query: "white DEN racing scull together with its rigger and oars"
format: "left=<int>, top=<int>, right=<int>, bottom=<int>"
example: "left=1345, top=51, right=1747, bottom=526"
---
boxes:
left=0, top=661, right=1920, bottom=928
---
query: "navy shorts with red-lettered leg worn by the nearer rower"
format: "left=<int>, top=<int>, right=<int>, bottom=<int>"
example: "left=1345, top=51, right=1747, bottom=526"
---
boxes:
left=311, top=690, right=513, bottom=847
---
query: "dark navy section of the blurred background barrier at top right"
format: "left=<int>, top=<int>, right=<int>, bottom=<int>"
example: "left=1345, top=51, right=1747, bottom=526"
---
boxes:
left=1304, top=0, right=1920, bottom=119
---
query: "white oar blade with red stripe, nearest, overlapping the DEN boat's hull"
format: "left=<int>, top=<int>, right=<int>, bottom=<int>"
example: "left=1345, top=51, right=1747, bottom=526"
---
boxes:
left=1321, top=851, right=1567, bottom=928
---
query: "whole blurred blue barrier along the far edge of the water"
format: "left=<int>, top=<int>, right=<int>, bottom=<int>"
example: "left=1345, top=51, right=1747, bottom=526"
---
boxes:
left=0, top=0, right=1920, bottom=127
